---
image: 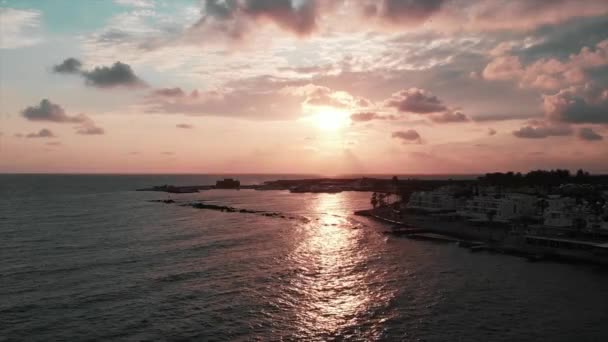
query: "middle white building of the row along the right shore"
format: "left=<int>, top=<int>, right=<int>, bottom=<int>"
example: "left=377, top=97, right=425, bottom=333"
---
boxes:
left=458, top=193, right=536, bottom=222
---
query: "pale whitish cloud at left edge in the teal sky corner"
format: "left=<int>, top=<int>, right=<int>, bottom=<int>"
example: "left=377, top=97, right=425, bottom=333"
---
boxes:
left=0, top=8, right=42, bottom=49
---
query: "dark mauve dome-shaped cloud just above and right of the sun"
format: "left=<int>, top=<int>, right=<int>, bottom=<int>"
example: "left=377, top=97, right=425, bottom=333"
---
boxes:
left=387, top=88, right=447, bottom=114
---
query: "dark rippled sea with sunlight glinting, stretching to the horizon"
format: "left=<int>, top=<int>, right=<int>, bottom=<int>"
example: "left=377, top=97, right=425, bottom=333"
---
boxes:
left=0, top=175, right=608, bottom=342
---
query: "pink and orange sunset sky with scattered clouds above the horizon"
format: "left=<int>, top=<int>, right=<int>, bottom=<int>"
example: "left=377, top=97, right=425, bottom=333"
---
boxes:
left=0, top=0, right=608, bottom=175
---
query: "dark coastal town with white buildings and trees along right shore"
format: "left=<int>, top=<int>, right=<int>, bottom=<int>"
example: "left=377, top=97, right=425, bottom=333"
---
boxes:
left=358, top=170, right=608, bottom=265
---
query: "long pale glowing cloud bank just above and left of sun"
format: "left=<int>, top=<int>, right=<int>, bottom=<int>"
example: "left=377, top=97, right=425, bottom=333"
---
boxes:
left=142, top=81, right=369, bottom=120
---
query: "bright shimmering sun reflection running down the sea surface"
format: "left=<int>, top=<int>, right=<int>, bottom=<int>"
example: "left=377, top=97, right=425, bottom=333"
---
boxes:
left=293, top=194, right=382, bottom=337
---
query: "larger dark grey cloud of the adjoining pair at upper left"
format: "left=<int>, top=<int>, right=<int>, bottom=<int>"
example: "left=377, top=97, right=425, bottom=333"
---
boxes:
left=82, top=62, right=145, bottom=88
